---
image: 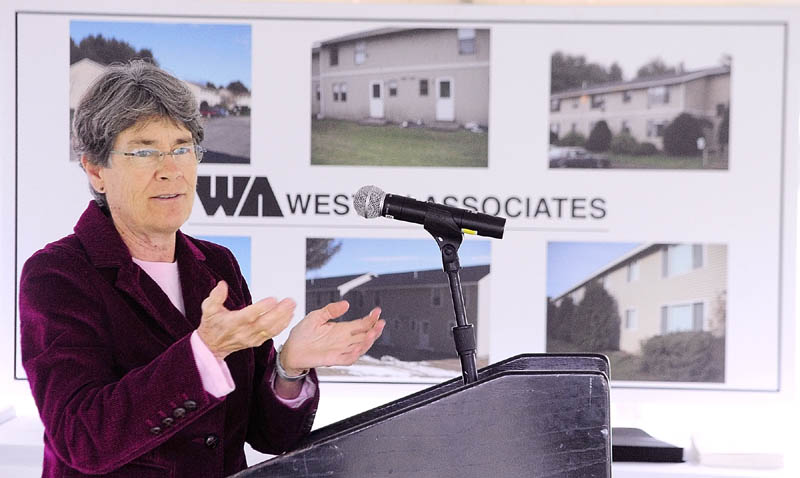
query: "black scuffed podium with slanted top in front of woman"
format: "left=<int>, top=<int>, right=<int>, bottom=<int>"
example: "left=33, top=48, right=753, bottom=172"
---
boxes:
left=233, top=354, right=611, bottom=478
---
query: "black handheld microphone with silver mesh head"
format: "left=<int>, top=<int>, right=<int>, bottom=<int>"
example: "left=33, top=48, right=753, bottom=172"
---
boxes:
left=353, top=186, right=506, bottom=239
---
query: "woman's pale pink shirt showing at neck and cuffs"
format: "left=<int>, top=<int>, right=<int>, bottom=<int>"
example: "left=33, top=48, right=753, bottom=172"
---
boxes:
left=133, top=257, right=316, bottom=408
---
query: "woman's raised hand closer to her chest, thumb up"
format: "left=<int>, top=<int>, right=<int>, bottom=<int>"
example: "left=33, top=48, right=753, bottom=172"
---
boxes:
left=197, top=281, right=297, bottom=360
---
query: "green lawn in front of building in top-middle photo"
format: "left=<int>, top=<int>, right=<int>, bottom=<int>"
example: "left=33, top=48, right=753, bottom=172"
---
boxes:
left=311, top=119, right=489, bottom=168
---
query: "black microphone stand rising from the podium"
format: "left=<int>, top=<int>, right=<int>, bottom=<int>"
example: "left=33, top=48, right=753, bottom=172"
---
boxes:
left=424, top=204, right=478, bottom=385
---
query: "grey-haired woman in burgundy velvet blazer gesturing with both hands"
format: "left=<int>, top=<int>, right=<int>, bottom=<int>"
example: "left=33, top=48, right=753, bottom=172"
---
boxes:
left=19, top=61, right=385, bottom=478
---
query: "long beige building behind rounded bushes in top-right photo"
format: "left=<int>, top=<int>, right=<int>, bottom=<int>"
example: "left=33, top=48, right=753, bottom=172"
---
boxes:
left=550, top=66, right=731, bottom=151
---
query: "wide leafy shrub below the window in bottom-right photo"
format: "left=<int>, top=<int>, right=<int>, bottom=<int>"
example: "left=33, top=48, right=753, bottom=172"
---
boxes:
left=642, top=332, right=725, bottom=382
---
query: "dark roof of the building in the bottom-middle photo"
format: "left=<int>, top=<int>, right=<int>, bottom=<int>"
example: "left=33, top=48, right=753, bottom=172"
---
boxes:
left=306, top=265, right=489, bottom=290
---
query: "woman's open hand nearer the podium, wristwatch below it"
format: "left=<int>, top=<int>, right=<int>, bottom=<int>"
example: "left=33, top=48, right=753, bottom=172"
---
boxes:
left=281, top=300, right=386, bottom=375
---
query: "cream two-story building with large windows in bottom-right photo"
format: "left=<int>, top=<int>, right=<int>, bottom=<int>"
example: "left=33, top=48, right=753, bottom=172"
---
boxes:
left=548, top=244, right=728, bottom=354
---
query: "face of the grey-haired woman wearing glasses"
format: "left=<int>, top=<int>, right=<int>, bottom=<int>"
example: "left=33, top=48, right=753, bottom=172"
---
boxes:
left=98, top=117, right=197, bottom=237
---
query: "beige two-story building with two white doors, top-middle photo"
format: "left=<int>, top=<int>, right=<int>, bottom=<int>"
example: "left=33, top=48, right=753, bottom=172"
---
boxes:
left=311, top=28, right=489, bottom=128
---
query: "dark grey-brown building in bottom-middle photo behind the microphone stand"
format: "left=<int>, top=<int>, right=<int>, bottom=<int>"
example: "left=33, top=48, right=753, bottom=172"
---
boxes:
left=306, top=265, right=489, bottom=360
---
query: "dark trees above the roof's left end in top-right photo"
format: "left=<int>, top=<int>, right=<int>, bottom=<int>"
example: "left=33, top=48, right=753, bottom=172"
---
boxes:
left=550, top=51, right=622, bottom=93
